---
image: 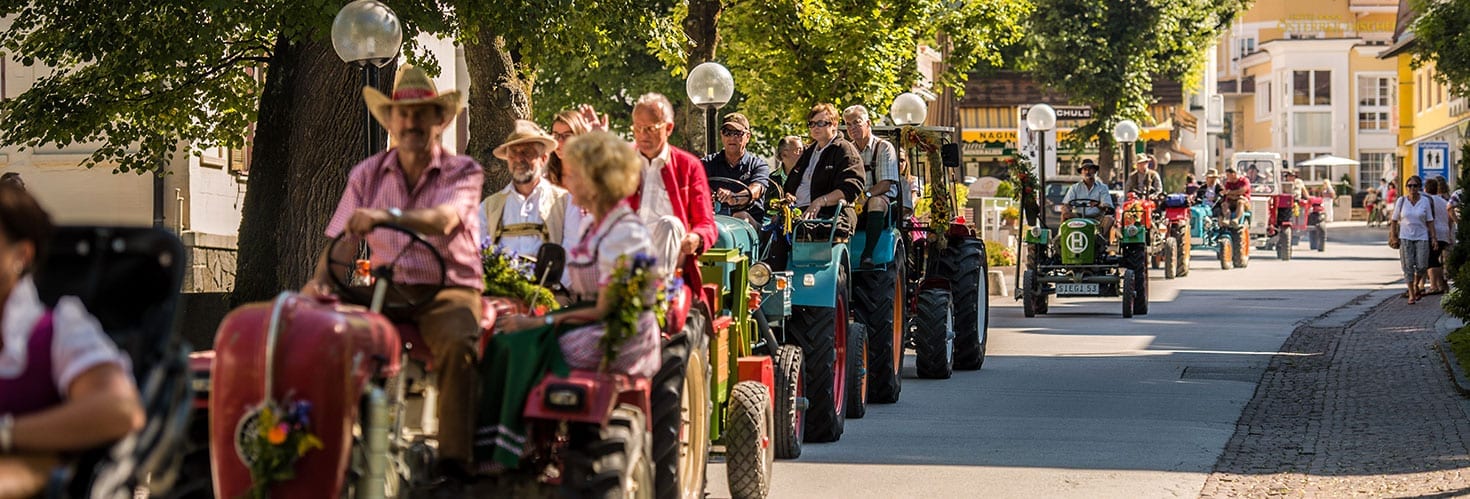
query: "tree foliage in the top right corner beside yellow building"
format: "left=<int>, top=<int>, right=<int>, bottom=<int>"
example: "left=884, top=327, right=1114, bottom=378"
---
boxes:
left=1413, top=0, right=1470, bottom=96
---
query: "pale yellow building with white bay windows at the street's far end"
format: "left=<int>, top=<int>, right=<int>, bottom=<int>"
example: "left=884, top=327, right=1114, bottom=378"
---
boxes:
left=1214, top=0, right=1398, bottom=190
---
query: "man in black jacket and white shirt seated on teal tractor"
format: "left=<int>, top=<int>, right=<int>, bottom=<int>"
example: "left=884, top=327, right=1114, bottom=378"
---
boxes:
left=769, top=103, right=867, bottom=271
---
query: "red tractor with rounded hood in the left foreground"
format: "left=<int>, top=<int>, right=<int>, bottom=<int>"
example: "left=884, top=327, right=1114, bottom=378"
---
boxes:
left=209, top=224, right=707, bottom=498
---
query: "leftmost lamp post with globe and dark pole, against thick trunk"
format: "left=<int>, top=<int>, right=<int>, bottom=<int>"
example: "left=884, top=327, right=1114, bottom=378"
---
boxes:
left=332, top=0, right=403, bottom=158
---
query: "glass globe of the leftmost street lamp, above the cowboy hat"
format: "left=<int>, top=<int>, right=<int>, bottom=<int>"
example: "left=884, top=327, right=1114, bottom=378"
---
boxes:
left=332, top=0, right=403, bottom=68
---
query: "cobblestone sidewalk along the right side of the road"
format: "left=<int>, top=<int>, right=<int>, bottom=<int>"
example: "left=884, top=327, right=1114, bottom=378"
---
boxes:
left=1201, top=296, right=1470, bottom=498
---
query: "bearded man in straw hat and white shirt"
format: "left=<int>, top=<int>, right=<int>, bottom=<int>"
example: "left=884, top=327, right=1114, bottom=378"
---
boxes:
left=479, top=119, right=567, bottom=255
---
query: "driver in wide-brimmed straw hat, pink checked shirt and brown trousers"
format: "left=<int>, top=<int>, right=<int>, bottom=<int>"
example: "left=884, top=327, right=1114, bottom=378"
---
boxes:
left=301, top=65, right=484, bottom=487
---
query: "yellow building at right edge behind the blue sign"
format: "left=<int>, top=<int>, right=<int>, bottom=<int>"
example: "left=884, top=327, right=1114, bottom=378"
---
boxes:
left=1380, top=0, right=1470, bottom=187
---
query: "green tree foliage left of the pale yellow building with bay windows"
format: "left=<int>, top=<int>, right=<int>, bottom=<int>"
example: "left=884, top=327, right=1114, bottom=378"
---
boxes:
left=1028, top=0, right=1251, bottom=158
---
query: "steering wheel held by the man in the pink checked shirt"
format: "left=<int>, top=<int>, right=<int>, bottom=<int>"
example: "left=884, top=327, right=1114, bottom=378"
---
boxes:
left=326, top=224, right=445, bottom=309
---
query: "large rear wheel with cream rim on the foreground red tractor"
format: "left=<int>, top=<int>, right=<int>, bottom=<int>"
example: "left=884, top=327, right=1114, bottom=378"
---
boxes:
left=650, top=308, right=710, bottom=499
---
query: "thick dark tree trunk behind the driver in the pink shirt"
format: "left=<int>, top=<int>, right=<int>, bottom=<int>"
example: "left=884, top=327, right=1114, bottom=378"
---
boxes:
left=232, top=37, right=394, bottom=305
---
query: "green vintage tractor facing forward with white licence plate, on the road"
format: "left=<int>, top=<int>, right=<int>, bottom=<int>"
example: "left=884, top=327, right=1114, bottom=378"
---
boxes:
left=1016, top=199, right=1152, bottom=318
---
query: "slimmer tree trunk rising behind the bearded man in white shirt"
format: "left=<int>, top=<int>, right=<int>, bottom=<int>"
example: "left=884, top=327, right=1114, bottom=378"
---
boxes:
left=465, top=34, right=532, bottom=194
